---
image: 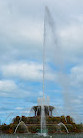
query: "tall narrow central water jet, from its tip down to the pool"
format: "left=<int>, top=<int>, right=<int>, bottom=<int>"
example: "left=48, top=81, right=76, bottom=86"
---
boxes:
left=41, top=7, right=56, bottom=134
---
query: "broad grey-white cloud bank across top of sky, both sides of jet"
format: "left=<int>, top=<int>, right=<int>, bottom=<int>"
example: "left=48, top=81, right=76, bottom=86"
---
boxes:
left=0, top=0, right=83, bottom=64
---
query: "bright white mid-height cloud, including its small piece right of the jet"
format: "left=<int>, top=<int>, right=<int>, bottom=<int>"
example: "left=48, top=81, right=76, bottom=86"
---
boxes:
left=2, top=62, right=55, bottom=81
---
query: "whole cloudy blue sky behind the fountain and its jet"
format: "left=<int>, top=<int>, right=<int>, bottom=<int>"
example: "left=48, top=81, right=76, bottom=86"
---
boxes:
left=0, top=0, right=83, bottom=123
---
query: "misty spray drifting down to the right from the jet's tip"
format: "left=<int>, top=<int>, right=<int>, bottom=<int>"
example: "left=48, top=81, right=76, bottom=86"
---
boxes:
left=43, top=7, right=77, bottom=121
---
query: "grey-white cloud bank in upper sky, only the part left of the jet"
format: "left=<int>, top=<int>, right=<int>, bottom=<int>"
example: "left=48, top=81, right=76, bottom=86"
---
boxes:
left=0, top=0, right=43, bottom=63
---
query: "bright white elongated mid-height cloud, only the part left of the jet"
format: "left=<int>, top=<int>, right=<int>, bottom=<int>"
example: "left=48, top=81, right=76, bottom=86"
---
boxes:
left=2, top=63, right=42, bottom=80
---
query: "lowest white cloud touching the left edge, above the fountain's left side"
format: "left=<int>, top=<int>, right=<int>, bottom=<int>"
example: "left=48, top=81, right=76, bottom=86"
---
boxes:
left=0, top=80, right=32, bottom=98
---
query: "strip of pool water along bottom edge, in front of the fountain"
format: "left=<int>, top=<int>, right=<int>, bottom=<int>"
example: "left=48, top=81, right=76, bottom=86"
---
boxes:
left=0, top=134, right=83, bottom=138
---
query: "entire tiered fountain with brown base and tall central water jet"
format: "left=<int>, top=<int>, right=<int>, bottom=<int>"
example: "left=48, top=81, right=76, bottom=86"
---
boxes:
left=0, top=7, right=83, bottom=136
